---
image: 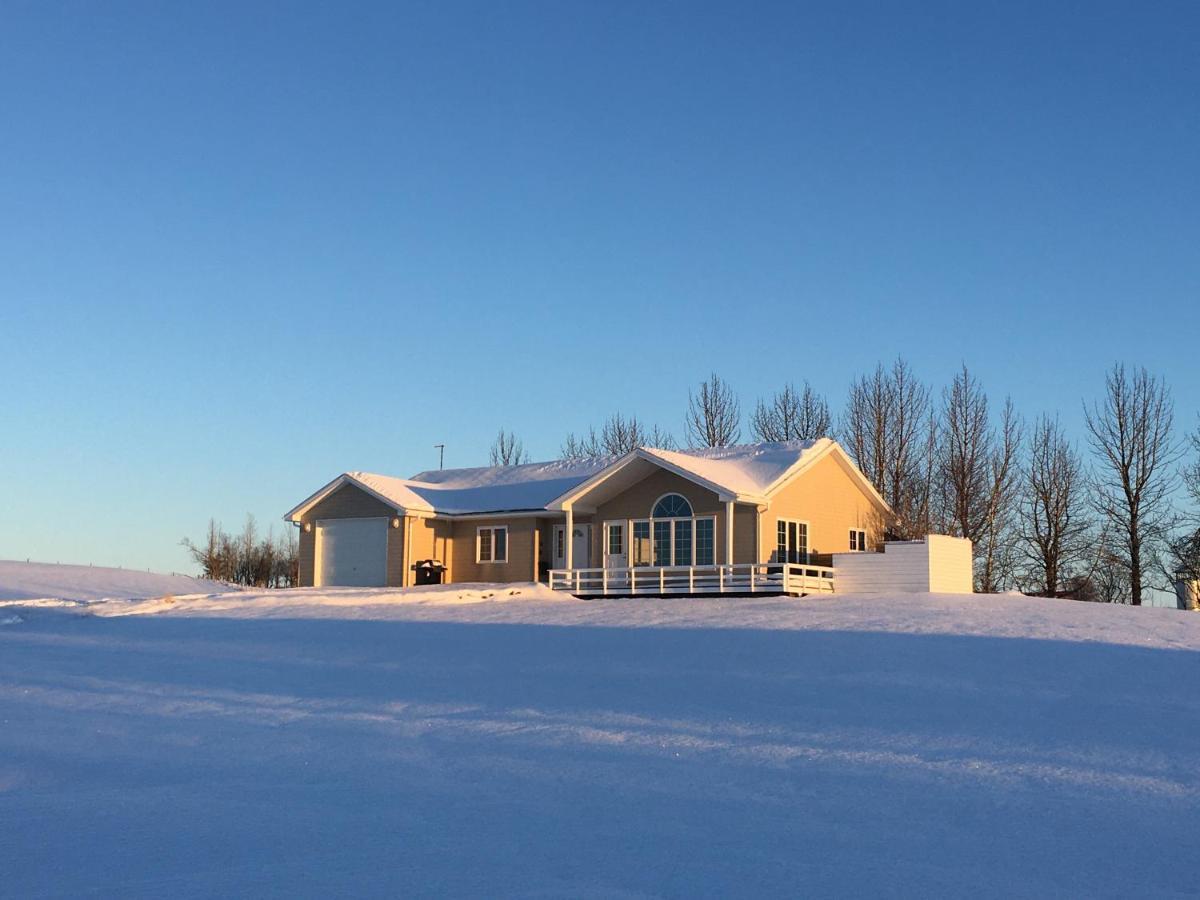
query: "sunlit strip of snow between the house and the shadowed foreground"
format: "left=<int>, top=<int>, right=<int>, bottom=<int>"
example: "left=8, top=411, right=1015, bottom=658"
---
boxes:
left=77, top=583, right=1200, bottom=649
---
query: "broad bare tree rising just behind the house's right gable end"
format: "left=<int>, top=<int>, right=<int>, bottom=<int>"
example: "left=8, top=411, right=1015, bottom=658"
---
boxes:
left=839, top=359, right=937, bottom=538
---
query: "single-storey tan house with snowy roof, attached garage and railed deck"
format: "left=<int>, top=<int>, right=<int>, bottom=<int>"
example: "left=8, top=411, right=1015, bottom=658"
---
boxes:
left=286, top=438, right=892, bottom=593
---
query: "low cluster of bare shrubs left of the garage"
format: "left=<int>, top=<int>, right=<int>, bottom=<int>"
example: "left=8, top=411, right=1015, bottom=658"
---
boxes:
left=181, top=516, right=300, bottom=588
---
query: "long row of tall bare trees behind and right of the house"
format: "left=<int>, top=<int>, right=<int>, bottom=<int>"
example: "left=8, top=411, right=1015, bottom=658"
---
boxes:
left=492, top=359, right=1200, bottom=604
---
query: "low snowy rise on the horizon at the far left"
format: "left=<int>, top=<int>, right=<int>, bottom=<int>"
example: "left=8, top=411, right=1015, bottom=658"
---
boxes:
left=0, top=560, right=233, bottom=601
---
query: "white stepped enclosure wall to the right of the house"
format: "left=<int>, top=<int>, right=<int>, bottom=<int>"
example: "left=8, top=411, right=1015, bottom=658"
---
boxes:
left=833, top=534, right=973, bottom=594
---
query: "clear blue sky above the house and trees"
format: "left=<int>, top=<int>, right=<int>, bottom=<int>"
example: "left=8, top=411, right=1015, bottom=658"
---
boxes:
left=0, top=1, right=1200, bottom=570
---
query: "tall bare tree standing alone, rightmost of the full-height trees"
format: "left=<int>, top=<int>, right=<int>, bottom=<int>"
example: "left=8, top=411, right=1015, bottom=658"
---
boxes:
left=1084, top=364, right=1180, bottom=606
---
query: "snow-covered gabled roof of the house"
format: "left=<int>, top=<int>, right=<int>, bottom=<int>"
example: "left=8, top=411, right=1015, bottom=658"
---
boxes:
left=284, top=438, right=889, bottom=521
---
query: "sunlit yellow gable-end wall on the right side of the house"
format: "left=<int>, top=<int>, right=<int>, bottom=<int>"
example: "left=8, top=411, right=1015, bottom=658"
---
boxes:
left=758, top=454, right=886, bottom=562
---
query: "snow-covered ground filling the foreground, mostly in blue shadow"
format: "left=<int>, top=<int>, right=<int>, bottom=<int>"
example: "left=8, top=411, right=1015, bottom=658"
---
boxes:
left=0, top=581, right=1200, bottom=896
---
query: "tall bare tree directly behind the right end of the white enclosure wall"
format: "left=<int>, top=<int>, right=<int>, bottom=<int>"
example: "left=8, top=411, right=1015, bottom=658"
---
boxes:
left=938, top=366, right=1022, bottom=592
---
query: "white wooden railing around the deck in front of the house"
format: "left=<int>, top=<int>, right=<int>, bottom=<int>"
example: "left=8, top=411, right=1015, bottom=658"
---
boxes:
left=550, top=563, right=833, bottom=596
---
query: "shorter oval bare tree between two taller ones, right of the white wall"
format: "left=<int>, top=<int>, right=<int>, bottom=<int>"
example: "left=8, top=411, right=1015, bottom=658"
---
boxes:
left=1020, top=415, right=1094, bottom=596
